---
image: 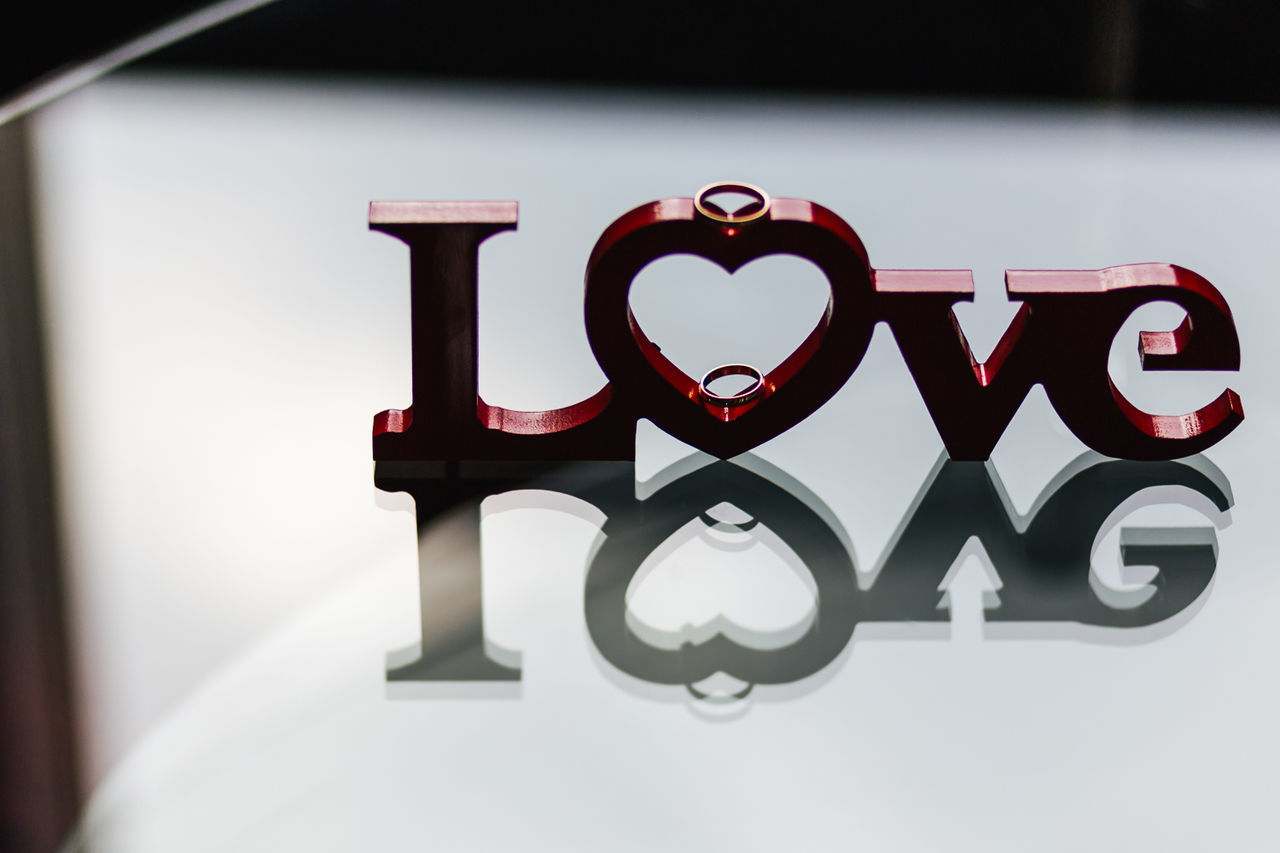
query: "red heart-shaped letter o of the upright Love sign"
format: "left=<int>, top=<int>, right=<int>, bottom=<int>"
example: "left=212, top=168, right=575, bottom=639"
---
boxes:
left=585, top=184, right=877, bottom=459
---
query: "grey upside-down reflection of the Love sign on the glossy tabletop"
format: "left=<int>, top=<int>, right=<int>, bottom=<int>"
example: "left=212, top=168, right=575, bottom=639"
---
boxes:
left=378, top=453, right=1233, bottom=698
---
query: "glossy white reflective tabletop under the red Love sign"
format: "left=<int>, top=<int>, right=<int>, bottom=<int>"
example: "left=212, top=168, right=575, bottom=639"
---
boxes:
left=36, top=76, right=1280, bottom=853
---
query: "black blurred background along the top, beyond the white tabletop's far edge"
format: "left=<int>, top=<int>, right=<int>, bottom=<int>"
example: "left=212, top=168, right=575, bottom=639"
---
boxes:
left=0, top=0, right=1280, bottom=106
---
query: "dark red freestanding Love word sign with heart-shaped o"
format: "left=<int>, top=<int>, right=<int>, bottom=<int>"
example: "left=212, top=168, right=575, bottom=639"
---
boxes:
left=370, top=178, right=1244, bottom=462
